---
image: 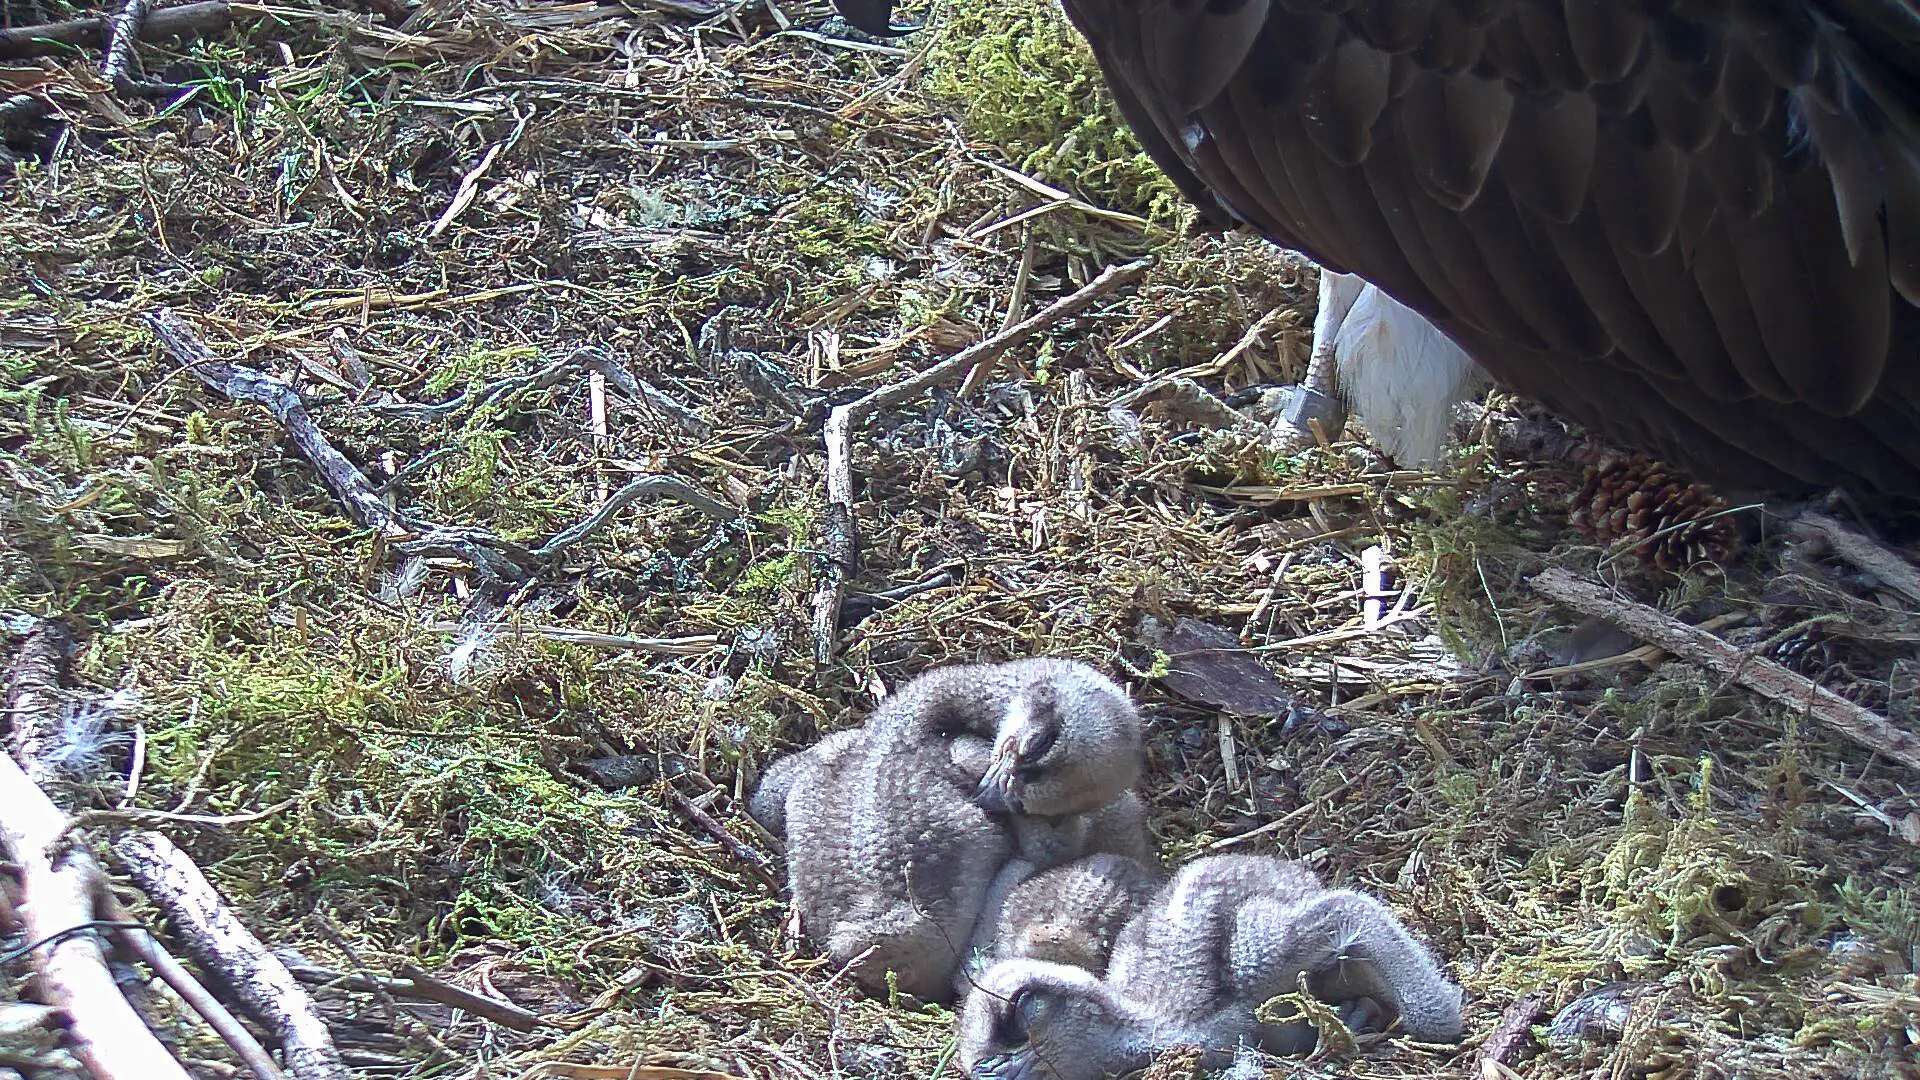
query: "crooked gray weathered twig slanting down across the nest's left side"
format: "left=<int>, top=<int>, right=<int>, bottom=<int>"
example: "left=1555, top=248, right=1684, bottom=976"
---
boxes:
left=146, top=307, right=411, bottom=536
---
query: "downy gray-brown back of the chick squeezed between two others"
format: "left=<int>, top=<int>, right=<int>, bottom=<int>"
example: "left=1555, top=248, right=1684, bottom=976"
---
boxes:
left=954, top=851, right=1164, bottom=997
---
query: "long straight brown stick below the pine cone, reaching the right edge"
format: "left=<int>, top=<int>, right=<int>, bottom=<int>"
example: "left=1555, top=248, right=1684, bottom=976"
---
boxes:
left=1532, top=567, right=1920, bottom=769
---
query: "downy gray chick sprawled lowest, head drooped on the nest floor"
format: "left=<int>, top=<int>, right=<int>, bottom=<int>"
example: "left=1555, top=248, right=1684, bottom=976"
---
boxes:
left=960, top=855, right=1461, bottom=1080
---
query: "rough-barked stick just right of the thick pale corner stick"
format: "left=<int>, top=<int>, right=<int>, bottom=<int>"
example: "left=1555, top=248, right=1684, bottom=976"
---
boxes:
left=113, top=832, right=348, bottom=1080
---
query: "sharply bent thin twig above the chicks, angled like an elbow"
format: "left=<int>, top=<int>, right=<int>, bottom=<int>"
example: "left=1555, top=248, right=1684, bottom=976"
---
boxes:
left=814, top=259, right=1152, bottom=665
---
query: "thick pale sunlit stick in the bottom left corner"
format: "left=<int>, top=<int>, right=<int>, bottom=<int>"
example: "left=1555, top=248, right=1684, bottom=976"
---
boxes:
left=0, top=753, right=188, bottom=1080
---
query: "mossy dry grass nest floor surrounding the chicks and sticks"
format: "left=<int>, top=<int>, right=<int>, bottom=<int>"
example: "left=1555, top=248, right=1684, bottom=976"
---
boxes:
left=0, top=0, right=1920, bottom=1080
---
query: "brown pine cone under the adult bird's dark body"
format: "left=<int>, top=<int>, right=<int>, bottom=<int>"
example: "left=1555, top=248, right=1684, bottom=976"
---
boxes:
left=1572, top=455, right=1741, bottom=573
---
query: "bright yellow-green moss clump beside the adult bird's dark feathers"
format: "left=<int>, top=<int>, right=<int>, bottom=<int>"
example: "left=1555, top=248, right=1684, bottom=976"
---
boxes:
left=924, top=0, right=1187, bottom=225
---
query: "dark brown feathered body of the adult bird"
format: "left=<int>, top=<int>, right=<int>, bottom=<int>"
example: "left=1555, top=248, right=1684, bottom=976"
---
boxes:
left=837, top=0, right=1920, bottom=498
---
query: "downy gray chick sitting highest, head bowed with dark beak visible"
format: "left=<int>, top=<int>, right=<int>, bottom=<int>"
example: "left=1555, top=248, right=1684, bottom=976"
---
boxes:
left=771, top=659, right=1148, bottom=999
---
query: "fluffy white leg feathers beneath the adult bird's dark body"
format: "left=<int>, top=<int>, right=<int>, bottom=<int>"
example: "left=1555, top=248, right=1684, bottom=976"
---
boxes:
left=1323, top=271, right=1482, bottom=467
